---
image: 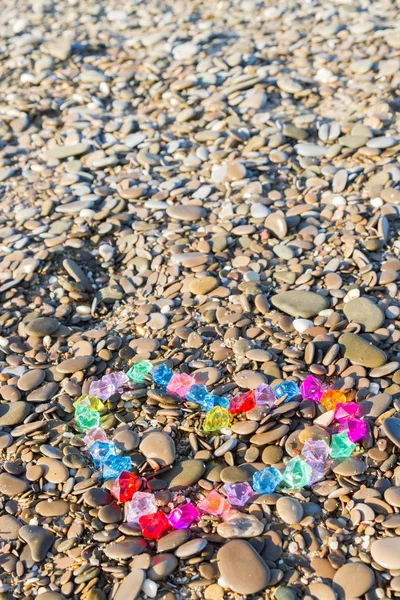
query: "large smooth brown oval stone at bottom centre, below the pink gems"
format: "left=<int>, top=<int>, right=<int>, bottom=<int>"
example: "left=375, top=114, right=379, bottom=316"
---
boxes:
left=217, top=540, right=270, bottom=595
